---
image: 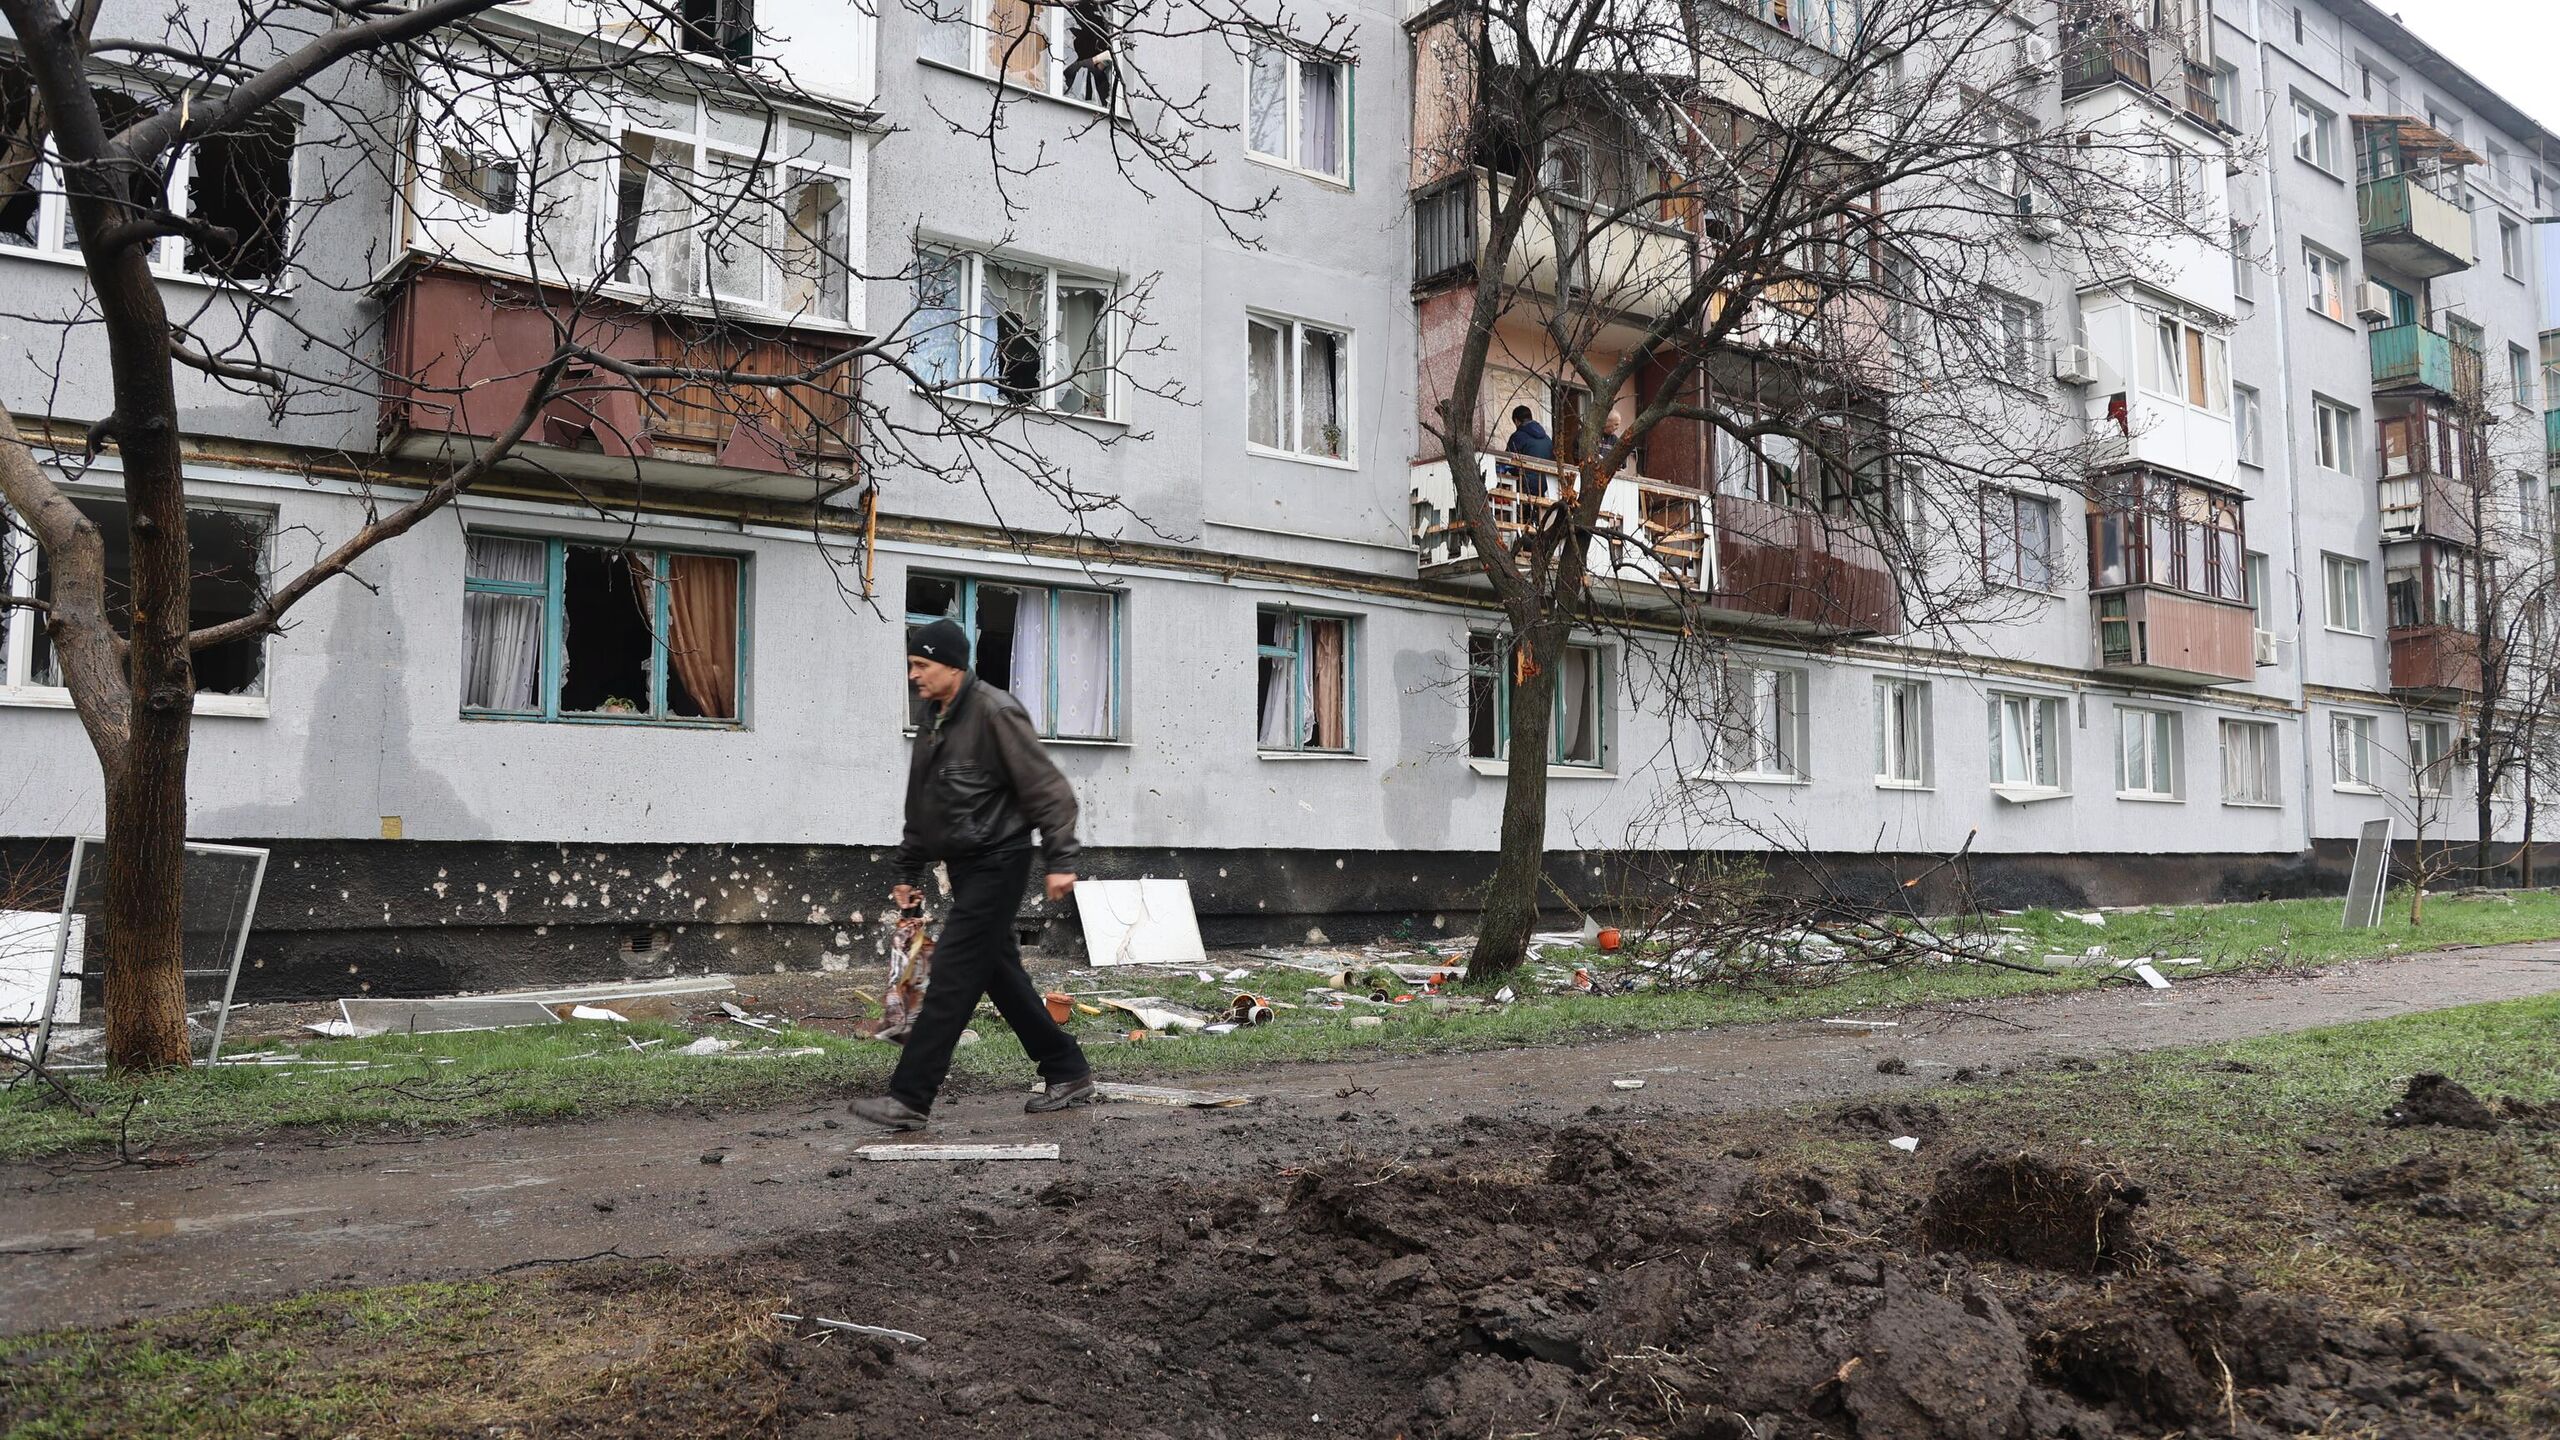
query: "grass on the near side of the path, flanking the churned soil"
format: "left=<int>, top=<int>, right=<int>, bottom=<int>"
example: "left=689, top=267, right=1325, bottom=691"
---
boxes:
left=15, top=997, right=2560, bottom=1440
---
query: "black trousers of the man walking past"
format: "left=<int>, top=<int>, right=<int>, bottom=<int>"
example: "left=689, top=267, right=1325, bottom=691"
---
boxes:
left=888, top=846, right=1093, bottom=1109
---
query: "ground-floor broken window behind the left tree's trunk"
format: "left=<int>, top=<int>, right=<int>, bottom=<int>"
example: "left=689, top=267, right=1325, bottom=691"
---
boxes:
left=0, top=495, right=274, bottom=697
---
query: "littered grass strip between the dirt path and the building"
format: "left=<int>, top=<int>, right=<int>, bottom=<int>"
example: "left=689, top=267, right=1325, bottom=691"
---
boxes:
left=15, top=892, right=2560, bottom=1158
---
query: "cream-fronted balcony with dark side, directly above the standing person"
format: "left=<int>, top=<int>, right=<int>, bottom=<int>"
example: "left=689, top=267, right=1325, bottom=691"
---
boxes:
left=1413, top=167, right=1697, bottom=315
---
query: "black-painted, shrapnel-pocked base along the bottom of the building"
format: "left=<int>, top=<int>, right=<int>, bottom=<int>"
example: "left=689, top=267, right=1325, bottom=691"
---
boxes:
left=0, top=840, right=2519, bottom=999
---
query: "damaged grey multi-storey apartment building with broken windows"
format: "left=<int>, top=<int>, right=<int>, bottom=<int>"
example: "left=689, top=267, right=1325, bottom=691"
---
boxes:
left=0, top=0, right=2560, bottom=994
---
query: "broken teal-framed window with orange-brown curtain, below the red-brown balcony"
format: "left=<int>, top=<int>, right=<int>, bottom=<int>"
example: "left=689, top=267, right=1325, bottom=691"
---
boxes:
left=461, top=530, right=745, bottom=725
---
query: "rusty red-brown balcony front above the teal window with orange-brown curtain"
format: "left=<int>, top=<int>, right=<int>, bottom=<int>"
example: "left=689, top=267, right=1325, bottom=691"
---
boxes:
left=384, top=266, right=858, bottom=500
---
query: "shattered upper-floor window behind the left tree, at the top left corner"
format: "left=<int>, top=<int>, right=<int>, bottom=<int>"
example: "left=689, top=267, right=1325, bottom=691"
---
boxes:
left=0, top=67, right=302, bottom=284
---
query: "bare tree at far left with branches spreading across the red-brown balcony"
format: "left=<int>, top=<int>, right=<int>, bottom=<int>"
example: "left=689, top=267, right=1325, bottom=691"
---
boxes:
left=0, top=0, right=1280, bottom=1068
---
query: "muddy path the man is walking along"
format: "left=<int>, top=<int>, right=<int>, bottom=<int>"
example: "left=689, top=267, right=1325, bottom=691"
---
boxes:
left=0, top=943, right=2560, bottom=1332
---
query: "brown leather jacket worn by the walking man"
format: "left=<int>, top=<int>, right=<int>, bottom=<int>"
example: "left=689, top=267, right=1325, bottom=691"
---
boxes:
left=899, top=676, right=1075, bottom=884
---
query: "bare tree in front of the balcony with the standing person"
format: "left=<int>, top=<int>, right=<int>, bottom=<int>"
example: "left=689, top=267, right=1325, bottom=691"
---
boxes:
left=1416, top=0, right=2237, bottom=974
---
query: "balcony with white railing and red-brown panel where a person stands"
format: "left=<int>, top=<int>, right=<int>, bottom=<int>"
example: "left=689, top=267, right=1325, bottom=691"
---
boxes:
left=1413, top=456, right=1902, bottom=635
